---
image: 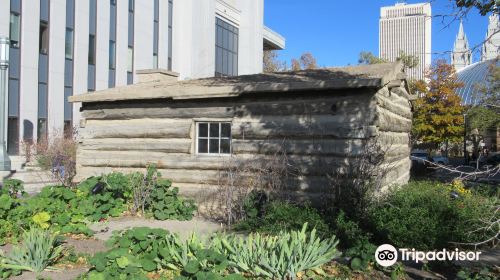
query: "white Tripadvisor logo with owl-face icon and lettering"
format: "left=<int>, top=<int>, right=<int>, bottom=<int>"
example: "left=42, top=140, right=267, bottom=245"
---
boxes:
left=375, top=244, right=481, bottom=267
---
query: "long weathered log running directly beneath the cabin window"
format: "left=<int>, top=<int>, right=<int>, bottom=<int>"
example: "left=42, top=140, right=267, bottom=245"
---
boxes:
left=77, top=146, right=409, bottom=178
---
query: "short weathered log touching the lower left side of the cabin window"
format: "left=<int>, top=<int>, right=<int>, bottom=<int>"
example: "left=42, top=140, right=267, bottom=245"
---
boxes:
left=80, top=138, right=193, bottom=154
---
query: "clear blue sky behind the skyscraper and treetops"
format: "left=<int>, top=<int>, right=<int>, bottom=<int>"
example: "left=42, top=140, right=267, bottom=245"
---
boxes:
left=264, top=0, right=488, bottom=66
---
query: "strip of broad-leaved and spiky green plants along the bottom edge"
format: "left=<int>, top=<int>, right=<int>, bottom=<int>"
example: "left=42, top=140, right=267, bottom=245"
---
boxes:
left=85, top=223, right=339, bottom=279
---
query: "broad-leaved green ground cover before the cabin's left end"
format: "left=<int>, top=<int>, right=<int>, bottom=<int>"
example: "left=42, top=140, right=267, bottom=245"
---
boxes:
left=0, top=166, right=196, bottom=245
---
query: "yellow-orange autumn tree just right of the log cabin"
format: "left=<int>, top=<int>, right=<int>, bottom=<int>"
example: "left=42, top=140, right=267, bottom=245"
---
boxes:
left=412, top=60, right=464, bottom=148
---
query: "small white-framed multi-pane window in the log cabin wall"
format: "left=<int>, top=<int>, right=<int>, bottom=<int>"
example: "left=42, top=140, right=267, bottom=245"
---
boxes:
left=196, top=122, right=231, bottom=155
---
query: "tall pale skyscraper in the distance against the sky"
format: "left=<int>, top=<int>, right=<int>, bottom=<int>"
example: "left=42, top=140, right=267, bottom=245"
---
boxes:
left=379, top=3, right=431, bottom=79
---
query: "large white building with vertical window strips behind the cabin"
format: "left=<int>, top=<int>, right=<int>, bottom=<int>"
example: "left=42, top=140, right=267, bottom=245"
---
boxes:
left=0, top=0, right=285, bottom=154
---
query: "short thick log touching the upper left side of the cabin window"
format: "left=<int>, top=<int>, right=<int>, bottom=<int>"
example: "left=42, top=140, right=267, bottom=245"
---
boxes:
left=81, top=119, right=193, bottom=139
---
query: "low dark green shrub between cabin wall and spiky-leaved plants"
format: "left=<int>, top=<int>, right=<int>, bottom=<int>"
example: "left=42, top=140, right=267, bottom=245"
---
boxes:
left=234, top=201, right=329, bottom=236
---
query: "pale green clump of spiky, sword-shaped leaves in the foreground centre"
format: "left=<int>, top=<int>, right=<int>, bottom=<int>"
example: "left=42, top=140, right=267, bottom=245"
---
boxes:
left=212, top=223, right=340, bottom=279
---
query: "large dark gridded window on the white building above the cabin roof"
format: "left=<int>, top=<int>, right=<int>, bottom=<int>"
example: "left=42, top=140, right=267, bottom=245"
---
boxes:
left=215, top=18, right=239, bottom=77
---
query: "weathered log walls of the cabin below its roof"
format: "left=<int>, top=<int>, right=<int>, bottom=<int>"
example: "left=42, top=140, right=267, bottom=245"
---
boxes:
left=77, top=87, right=411, bottom=198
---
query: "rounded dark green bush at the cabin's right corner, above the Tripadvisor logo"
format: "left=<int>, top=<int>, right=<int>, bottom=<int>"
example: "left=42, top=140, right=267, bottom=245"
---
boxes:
left=368, top=182, right=499, bottom=250
